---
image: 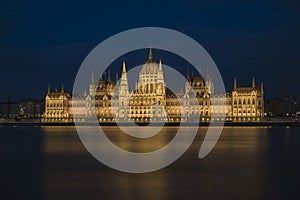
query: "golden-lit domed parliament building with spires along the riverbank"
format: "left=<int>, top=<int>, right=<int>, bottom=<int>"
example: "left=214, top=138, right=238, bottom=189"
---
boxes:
left=43, top=49, right=264, bottom=122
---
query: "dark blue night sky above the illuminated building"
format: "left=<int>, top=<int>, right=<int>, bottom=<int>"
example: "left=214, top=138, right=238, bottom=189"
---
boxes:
left=0, top=0, right=300, bottom=101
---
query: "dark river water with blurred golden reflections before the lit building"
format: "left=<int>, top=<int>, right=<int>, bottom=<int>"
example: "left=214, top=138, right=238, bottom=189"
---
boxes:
left=0, top=127, right=300, bottom=200
